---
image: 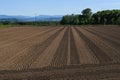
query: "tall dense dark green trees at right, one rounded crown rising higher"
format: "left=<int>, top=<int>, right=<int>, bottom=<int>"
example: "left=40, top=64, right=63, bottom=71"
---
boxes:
left=60, top=8, right=120, bottom=25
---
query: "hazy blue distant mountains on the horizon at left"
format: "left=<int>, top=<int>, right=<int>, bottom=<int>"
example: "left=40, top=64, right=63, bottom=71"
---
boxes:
left=0, top=15, right=63, bottom=22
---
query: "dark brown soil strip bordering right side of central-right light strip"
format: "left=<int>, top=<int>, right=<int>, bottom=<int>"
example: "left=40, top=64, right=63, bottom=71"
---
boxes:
left=76, top=28, right=112, bottom=63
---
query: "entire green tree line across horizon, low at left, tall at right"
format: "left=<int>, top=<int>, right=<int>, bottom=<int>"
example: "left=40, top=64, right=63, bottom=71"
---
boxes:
left=0, top=8, right=120, bottom=26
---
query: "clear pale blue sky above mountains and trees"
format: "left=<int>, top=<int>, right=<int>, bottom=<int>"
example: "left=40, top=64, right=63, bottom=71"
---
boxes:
left=0, top=0, right=120, bottom=16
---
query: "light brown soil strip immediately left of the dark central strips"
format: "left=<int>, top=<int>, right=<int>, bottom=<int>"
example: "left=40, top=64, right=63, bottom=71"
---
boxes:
left=31, top=28, right=66, bottom=68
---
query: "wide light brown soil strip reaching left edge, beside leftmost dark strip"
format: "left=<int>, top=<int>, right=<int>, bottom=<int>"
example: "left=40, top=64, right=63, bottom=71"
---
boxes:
left=0, top=29, right=57, bottom=66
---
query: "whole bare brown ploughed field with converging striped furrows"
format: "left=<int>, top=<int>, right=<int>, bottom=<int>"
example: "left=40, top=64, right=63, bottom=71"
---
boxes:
left=0, top=26, right=120, bottom=80
